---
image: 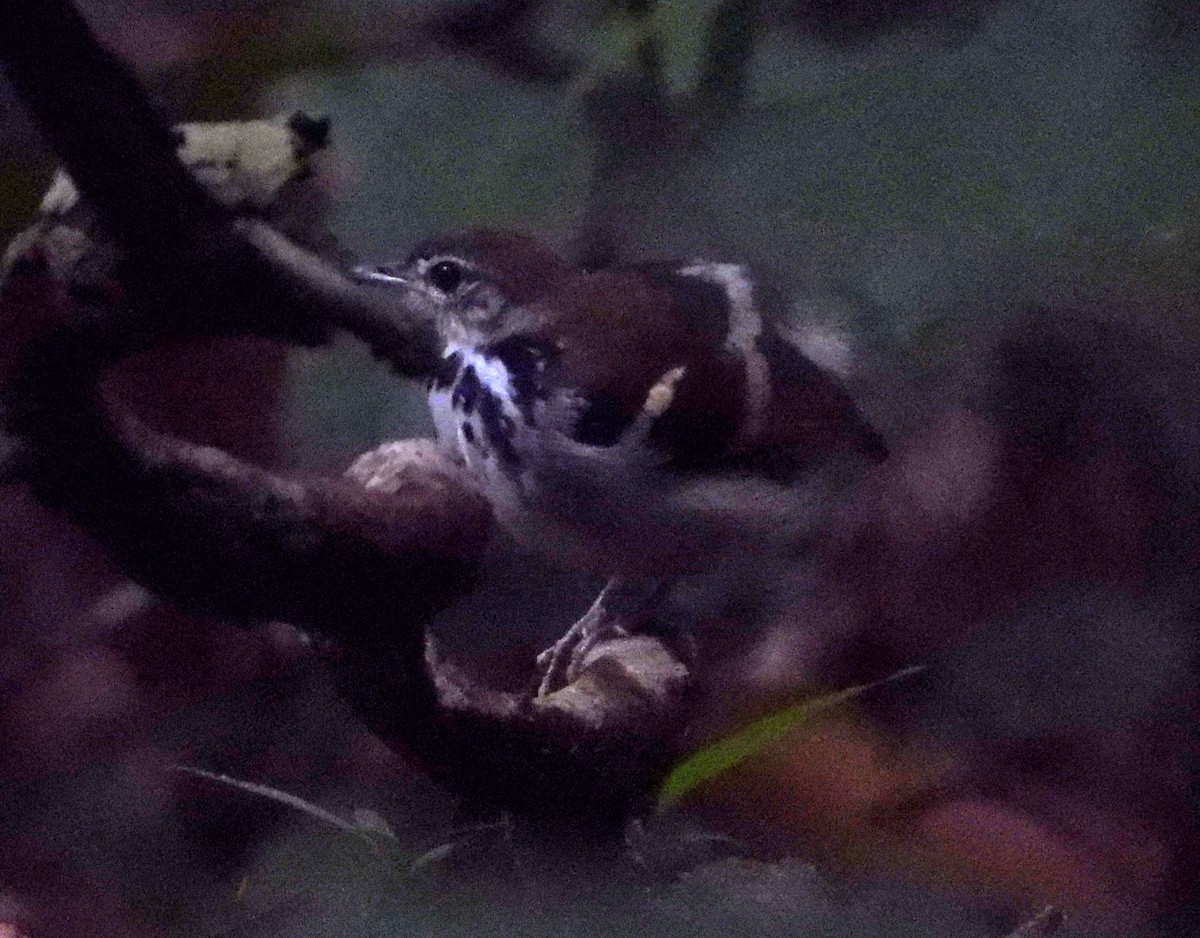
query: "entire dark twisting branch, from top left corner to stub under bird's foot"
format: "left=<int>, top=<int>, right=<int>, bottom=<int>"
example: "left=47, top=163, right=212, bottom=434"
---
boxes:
left=0, top=0, right=688, bottom=828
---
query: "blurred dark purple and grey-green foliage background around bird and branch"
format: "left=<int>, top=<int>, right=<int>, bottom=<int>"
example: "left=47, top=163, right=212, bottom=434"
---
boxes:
left=0, top=0, right=1200, bottom=936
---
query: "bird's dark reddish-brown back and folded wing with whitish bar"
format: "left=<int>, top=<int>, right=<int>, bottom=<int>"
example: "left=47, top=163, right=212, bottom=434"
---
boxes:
left=480, top=261, right=887, bottom=477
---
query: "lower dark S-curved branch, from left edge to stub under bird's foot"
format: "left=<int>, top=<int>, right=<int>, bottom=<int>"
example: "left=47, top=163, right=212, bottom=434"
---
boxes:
left=5, top=291, right=688, bottom=830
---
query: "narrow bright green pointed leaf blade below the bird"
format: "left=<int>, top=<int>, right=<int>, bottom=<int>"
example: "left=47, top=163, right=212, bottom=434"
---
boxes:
left=658, top=665, right=924, bottom=811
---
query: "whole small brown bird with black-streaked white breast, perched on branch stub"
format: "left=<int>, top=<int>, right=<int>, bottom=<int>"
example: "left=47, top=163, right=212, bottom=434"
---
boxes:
left=352, top=229, right=888, bottom=696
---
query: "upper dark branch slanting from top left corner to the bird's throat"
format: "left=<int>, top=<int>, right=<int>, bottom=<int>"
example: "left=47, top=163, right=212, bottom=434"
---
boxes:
left=0, top=0, right=437, bottom=377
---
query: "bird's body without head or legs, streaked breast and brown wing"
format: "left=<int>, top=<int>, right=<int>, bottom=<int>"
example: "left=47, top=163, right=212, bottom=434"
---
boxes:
left=417, top=251, right=887, bottom=572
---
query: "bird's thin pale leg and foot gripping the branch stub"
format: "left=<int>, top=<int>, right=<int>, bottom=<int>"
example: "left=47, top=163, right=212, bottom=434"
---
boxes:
left=538, top=577, right=662, bottom=697
